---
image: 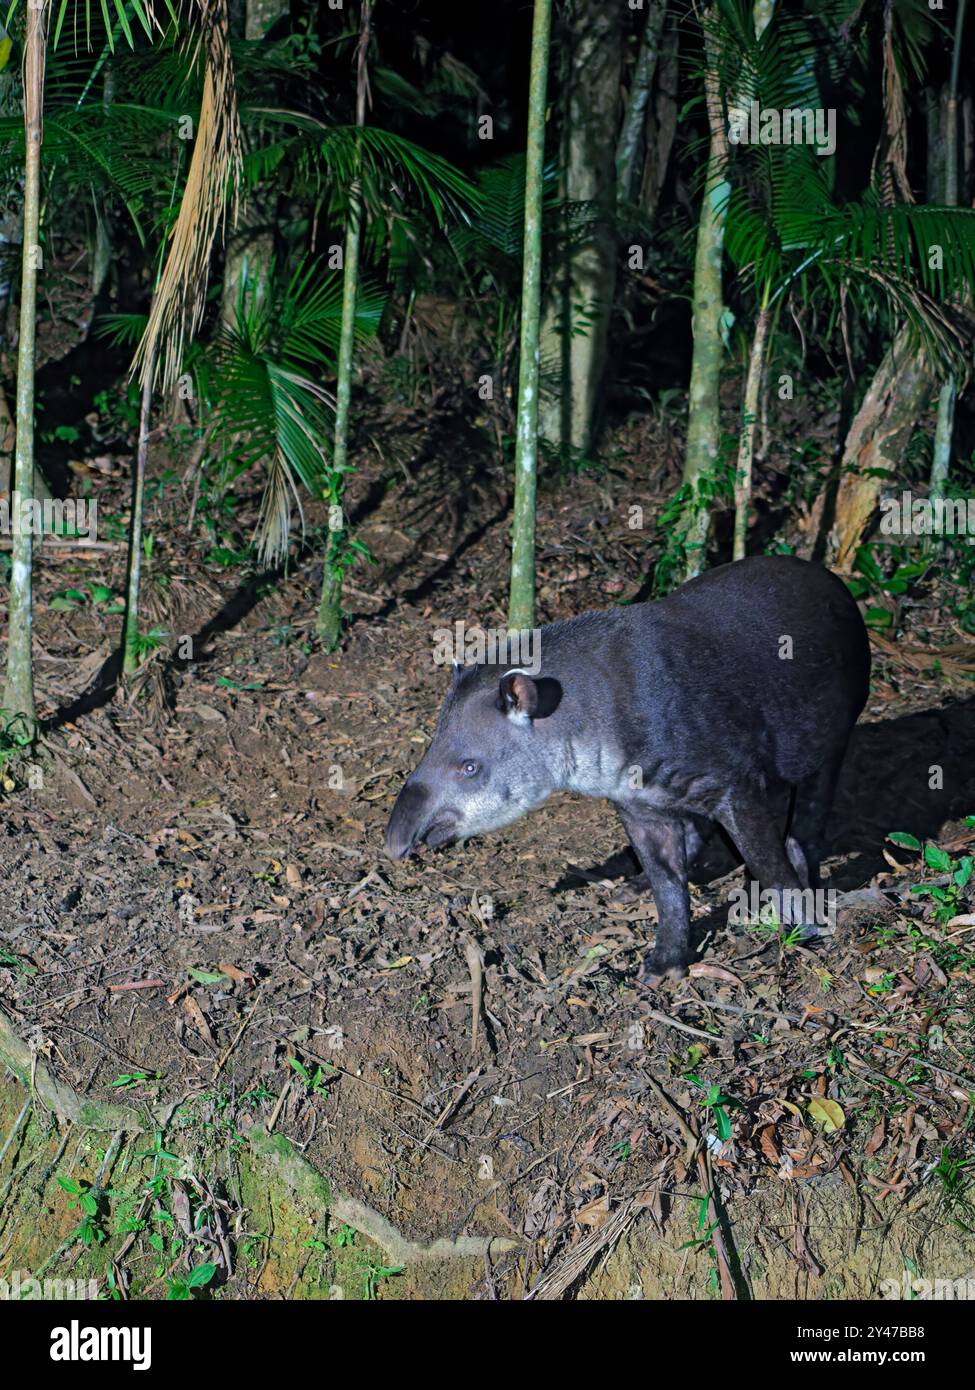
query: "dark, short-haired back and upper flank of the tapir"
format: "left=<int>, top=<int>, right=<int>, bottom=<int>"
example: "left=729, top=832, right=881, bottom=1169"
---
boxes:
left=542, top=556, right=869, bottom=781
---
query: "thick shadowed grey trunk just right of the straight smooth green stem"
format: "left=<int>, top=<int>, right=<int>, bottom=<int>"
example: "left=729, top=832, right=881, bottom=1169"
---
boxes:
left=538, top=0, right=623, bottom=452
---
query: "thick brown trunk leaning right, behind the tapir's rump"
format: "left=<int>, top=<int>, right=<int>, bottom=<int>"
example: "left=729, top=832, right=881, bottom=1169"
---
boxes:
left=828, top=327, right=933, bottom=574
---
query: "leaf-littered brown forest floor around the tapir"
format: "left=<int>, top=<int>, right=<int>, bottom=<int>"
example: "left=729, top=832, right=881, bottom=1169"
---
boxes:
left=0, top=328, right=975, bottom=1298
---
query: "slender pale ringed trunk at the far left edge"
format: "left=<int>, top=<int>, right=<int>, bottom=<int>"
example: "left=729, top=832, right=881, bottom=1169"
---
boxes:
left=3, top=0, right=47, bottom=726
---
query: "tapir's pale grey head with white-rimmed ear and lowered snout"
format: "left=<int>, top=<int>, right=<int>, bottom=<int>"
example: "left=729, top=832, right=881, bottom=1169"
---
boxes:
left=385, top=666, right=562, bottom=859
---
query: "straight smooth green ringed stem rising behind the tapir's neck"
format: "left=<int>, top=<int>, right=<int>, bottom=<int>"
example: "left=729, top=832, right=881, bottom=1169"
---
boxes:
left=508, top=0, right=552, bottom=631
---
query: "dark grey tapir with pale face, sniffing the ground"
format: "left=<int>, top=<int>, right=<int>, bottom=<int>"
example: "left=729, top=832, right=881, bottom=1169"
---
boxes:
left=385, top=556, right=871, bottom=988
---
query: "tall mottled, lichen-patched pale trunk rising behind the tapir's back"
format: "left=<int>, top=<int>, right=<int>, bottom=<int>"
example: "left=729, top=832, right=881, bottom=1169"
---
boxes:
left=683, top=10, right=730, bottom=580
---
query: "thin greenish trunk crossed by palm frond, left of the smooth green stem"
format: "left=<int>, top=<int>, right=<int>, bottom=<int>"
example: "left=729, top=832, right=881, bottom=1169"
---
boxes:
left=316, top=0, right=373, bottom=652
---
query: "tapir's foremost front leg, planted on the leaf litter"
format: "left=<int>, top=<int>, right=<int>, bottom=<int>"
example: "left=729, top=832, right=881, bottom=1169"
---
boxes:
left=618, top=806, right=691, bottom=988
